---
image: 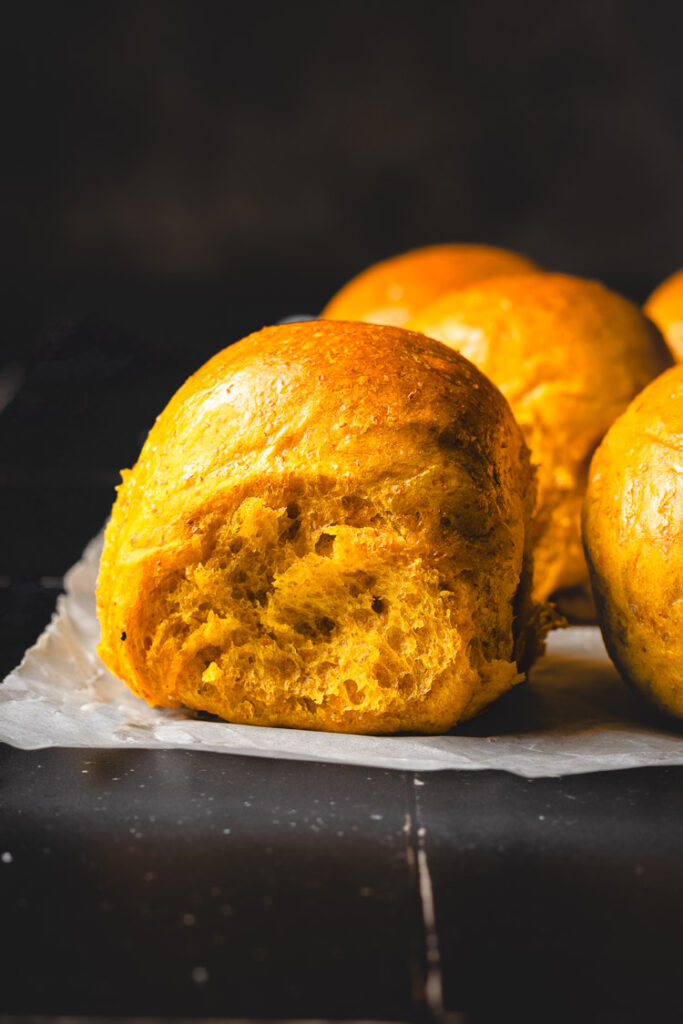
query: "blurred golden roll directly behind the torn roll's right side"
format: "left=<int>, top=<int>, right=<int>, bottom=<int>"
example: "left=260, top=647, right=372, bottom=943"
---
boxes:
left=410, top=273, right=672, bottom=600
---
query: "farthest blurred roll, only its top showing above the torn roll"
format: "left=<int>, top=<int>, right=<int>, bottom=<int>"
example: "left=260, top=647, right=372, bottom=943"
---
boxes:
left=323, top=244, right=537, bottom=327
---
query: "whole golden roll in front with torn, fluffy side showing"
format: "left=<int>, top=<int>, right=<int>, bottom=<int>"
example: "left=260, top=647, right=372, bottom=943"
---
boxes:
left=97, top=322, right=538, bottom=732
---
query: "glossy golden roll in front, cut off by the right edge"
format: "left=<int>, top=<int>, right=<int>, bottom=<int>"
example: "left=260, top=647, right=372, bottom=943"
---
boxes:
left=584, top=367, right=683, bottom=717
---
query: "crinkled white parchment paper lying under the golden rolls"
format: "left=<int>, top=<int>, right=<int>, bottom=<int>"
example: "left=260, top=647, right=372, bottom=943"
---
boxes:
left=0, top=537, right=683, bottom=778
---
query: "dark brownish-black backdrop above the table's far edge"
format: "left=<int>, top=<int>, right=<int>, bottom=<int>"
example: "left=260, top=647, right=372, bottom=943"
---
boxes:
left=2, top=0, right=683, bottom=333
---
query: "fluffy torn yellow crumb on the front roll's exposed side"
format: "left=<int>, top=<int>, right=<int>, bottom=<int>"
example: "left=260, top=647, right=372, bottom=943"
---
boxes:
left=129, top=493, right=521, bottom=732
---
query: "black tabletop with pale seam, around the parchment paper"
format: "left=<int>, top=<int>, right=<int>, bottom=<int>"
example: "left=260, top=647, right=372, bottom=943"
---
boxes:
left=0, top=287, right=683, bottom=1024
